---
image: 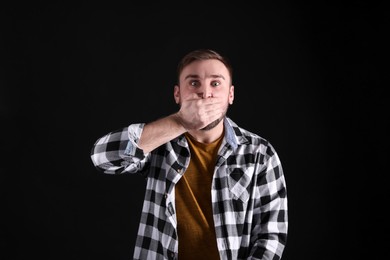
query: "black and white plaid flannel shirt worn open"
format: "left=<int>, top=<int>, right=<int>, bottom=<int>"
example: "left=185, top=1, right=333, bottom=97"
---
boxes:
left=91, top=117, right=288, bottom=260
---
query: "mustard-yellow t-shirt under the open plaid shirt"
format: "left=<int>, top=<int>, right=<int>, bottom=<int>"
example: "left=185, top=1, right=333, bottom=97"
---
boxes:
left=175, top=134, right=223, bottom=260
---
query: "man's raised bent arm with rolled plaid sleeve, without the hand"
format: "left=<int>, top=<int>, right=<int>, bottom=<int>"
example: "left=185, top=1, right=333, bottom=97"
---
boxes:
left=91, top=114, right=186, bottom=174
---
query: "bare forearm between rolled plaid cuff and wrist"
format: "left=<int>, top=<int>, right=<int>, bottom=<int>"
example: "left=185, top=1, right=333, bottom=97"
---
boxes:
left=138, top=114, right=186, bottom=153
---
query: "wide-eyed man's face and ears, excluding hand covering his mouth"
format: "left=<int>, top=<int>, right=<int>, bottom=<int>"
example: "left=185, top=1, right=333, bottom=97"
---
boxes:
left=174, top=59, right=234, bottom=130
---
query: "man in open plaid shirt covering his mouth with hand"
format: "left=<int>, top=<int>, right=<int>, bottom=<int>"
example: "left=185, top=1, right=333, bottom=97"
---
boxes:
left=91, top=49, right=288, bottom=260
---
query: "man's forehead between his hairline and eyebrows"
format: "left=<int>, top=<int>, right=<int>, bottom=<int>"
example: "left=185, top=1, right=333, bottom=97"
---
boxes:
left=180, top=59, right=229, bottom=80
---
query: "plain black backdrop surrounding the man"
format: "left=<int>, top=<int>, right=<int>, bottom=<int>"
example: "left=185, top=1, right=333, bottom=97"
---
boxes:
left=0, top=1, right=390, bottom=260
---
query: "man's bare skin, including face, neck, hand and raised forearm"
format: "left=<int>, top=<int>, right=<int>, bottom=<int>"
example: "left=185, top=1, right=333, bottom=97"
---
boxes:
left=138, top=59, right=234, bottom=153
